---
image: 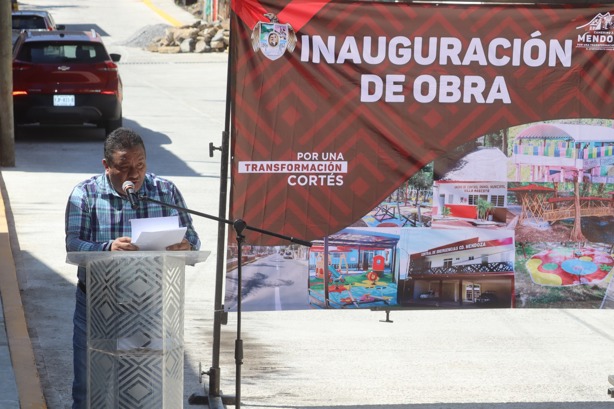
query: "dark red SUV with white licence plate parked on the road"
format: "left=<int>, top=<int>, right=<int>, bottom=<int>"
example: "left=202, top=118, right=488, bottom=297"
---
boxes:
left=13, top=30, right=123, bottom=134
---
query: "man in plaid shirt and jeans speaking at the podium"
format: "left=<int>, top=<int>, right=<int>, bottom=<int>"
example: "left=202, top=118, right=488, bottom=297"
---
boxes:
left=66, top=128, right=200, bottom=409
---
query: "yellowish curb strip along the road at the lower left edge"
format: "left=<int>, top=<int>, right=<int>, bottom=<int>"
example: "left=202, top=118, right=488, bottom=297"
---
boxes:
left=0, top=172, right=47, bottom=409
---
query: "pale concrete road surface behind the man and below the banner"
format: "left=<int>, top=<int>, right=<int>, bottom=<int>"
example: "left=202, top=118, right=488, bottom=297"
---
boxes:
left=2, top=0, right=614, bottom=409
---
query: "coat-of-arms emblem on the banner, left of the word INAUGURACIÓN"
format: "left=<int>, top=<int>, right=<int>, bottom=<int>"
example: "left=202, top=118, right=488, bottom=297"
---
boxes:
left=252, top=13, right=296, bottom=61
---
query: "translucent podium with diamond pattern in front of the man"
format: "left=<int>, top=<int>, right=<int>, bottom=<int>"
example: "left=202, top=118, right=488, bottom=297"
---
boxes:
left=67, top=251, right=210, bottom=409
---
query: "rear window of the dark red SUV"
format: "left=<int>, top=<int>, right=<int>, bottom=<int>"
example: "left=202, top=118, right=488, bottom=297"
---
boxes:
left=17, top=42, right=109, bottom=64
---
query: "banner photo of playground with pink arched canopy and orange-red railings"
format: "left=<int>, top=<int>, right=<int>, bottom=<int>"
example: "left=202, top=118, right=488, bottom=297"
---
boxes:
left=508, top=119, right=614, bottom=244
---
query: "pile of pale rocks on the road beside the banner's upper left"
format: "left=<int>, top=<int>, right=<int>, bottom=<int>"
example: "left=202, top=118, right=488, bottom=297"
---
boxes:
left=145, top=20, right=230, bottom=54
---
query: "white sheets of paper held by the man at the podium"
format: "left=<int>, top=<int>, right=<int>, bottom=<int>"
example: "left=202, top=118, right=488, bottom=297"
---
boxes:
left=130, top=216, right=187, bottom=251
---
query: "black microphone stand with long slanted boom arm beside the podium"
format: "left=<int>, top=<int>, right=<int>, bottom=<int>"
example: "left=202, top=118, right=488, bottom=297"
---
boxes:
left=137, top=194, right=311, bottom=409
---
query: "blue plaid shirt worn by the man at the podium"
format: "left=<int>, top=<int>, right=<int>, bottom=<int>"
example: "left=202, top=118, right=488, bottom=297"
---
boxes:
left=66, top=173, right=200, bottom=280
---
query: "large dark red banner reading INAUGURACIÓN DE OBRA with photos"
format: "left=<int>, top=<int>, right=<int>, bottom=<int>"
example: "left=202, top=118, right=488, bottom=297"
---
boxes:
left=226, top=0, right=614, bottom=310
